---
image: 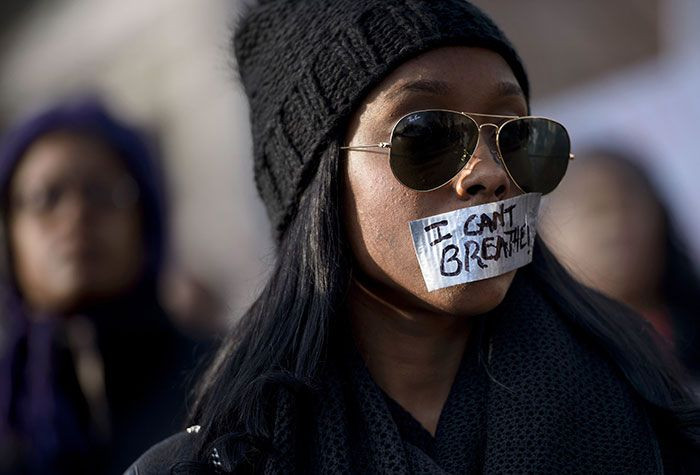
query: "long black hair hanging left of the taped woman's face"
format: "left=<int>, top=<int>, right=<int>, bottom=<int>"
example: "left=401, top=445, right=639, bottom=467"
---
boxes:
left=191, top=146, right=352, bottom=450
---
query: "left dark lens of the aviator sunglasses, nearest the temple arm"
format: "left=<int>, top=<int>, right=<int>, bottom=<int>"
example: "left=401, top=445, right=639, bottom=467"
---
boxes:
left=389, top=110, right=479, bottom=191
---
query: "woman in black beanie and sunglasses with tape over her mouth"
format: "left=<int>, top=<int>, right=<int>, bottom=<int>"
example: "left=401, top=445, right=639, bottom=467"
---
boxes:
left=131, top=0, right=698, bottom=473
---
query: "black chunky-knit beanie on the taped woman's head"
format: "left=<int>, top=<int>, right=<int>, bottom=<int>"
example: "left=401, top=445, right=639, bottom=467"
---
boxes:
left=234, top=0, right=529, bottom=240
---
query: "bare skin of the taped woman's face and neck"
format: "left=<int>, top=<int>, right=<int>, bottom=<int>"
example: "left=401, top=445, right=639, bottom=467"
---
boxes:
left=344, top=47, right=527, bottom=434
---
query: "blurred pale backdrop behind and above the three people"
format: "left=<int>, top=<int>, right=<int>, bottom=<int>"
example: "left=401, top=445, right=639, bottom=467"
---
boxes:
left=0, top=0, right=700, bottom=324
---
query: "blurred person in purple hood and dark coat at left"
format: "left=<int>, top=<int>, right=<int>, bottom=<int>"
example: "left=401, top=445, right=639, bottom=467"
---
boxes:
left=0, top=98, right=196, bottom=474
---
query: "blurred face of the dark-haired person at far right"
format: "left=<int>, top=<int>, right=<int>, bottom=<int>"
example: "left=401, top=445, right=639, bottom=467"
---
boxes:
left=543, top=156, right=666, bottom=314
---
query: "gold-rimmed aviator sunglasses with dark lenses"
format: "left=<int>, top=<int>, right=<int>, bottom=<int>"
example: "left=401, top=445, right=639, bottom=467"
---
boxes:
left=341, top=109, right=574, bottom=194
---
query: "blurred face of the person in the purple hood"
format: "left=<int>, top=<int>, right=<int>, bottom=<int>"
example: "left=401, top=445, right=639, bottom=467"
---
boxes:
left=8, top=132, right=144, bottom=318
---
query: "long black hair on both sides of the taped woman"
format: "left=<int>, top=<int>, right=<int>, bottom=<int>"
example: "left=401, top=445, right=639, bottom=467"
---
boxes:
left=191, top=145, right=700, bottom=464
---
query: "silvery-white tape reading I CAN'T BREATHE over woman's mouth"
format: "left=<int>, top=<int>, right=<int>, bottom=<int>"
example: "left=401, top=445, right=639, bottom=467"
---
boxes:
left=409, top=193, right=541, bottom=292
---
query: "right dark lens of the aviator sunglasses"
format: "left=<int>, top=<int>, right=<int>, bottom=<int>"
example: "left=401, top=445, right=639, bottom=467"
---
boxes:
left=498, top=117, right=571, bottom=194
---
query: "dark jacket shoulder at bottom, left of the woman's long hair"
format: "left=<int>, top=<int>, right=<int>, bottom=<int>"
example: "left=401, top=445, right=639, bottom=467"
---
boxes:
left=124, top=426, right=205, bottom=475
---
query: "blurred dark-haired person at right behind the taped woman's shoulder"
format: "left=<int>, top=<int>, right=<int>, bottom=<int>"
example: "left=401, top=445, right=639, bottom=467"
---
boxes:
left=541, top=149, right=700, bottom=380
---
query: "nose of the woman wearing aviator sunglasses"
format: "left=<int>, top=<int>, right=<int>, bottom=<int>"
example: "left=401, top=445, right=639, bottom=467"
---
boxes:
left=454, top=127, right=512, bottom=204
